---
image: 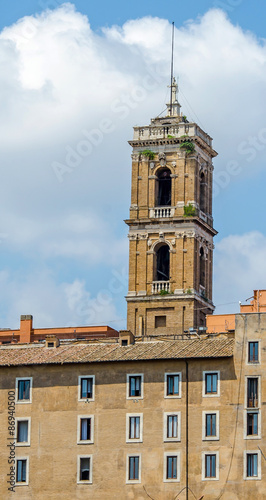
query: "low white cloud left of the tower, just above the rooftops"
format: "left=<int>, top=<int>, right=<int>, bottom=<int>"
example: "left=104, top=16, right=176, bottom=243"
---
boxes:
left=0, top=269, right=125, bottom=328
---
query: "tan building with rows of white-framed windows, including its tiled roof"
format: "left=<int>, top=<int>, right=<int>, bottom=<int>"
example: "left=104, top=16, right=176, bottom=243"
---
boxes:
left=0, top=313, right=266, bottom=500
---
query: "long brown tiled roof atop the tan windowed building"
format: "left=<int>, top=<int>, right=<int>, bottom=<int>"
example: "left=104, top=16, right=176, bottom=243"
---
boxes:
left=0, top=339, right=234, bottom=366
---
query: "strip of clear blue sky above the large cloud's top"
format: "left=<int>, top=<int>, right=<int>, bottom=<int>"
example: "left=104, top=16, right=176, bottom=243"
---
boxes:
left=0, top=0, right=266, bottom=38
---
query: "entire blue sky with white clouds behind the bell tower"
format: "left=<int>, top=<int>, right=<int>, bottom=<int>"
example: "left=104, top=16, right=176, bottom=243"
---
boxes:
left=0, top=0, right=266, bottom=328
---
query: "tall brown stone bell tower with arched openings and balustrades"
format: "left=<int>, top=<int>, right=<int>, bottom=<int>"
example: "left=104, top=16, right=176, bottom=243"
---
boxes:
left=126, top=78, right=217, bottom=336
